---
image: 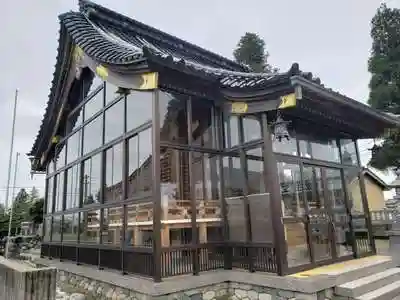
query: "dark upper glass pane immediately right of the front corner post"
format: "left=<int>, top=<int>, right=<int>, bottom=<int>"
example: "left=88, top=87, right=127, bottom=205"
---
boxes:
left=159, top=92, right=189, bottom=145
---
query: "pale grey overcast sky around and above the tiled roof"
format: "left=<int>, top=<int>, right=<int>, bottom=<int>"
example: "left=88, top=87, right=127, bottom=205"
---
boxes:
left=0, top=0, right=400, bottom=202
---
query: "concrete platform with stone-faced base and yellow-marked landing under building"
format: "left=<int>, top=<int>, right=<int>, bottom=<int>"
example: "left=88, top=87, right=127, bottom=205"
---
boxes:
left=37, top=256, right=393, bottom=300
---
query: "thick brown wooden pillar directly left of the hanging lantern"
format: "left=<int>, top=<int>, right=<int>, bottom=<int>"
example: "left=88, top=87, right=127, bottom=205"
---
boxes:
left=261, top=112, right=288, bottom=276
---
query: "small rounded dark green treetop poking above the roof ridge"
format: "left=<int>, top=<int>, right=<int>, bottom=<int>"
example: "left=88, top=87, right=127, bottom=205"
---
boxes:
left=233, top=32, right=277, bottom=73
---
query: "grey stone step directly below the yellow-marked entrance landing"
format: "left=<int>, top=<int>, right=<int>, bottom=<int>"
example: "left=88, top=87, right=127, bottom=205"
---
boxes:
left=335, top=268, right=400, bottom=298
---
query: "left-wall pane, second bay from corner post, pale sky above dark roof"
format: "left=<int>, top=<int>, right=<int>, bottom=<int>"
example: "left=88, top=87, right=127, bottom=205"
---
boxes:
left=104, top=143, right=122, bottom=202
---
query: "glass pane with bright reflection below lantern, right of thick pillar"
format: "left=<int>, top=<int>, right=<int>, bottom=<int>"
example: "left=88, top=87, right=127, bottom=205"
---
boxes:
left=278, top=162, right=305, bottom=217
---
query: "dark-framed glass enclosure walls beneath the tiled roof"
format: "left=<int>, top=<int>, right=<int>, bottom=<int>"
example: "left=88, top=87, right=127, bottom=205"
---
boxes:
left=42, top=74, right=374, bottom=281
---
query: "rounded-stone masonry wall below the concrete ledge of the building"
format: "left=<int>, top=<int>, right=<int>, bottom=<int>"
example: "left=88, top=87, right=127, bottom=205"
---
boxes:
left=58, top=271, right=334, bottom=300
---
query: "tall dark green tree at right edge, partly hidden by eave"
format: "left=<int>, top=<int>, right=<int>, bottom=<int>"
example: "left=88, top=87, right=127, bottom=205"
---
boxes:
left=368, top=4, right=400, bottom=170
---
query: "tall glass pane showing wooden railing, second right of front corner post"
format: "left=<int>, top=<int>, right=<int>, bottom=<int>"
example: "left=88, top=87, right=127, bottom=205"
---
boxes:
left=192, top=152, right=222, bottom=243
